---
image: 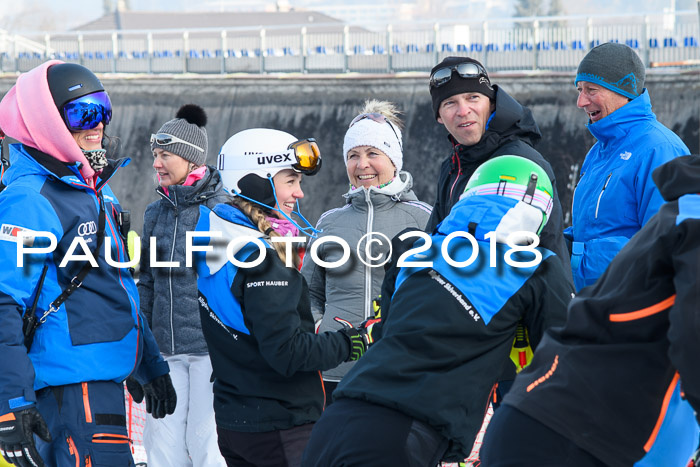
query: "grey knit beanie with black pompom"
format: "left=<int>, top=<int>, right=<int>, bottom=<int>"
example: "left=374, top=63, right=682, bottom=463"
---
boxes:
left=151, top=104, right=209, bottom=166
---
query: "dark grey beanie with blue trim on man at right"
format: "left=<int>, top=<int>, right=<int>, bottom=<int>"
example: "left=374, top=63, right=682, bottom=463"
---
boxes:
left=574, top=42, right=645, bottom=99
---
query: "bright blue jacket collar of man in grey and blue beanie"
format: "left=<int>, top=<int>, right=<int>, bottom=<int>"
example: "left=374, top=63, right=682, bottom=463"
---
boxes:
left=587, top=89, right=656, bottom=144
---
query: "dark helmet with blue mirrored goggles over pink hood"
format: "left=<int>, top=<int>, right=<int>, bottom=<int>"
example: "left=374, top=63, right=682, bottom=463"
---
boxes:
left=46, top=63, right=112, bottom=131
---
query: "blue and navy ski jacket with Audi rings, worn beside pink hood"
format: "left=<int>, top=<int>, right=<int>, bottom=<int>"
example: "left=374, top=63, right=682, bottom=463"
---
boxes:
left=0, top=144, right=168, bottom=414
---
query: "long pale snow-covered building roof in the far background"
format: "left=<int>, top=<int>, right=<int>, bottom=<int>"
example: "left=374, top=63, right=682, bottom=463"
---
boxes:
left=74, top=11, right=352, bottom=31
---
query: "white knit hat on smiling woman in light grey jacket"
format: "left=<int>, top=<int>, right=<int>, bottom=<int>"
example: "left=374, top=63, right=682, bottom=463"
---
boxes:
left=343, top=118, right=403, bottom=173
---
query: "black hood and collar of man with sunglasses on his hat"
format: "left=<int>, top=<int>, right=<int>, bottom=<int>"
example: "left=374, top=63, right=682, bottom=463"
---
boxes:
left=449, top=85, right=542, bottom=154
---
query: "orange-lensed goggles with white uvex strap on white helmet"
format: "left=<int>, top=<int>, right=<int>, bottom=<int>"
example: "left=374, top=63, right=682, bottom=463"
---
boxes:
left=218, top=138, right=321, bottom=175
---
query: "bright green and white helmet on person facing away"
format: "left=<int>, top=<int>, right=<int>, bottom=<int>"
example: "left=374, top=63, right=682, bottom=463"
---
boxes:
left=461, top=156, right=554, bottom=239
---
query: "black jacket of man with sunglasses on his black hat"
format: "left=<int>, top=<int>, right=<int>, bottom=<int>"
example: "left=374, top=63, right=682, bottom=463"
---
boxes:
left=425, top=86, right=573, bottom=283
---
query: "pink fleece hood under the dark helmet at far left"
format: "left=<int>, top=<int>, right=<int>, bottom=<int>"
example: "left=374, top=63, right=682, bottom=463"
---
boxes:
left=0, top=60, right=95, bottom=180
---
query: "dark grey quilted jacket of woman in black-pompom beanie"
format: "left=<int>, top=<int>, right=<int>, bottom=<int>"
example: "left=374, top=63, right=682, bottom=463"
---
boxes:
left=138, top=166, right=231, bottom=355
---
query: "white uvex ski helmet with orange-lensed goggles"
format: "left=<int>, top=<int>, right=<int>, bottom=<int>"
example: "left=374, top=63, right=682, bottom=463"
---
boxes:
left=217, top=128, right=321, bottom=208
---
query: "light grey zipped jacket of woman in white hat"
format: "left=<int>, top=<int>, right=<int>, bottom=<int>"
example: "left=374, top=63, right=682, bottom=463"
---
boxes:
left=301, top=172, right=431, bottom=381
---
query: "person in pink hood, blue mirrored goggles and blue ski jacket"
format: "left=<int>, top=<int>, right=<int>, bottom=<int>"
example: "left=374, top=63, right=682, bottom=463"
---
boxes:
left=0, top=60, right=176, bottom=467
